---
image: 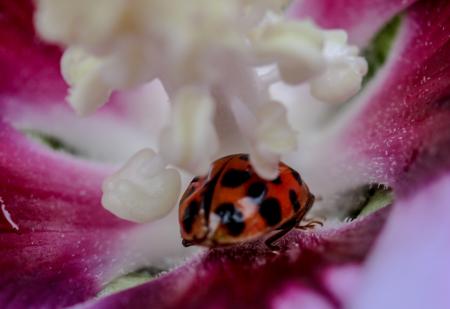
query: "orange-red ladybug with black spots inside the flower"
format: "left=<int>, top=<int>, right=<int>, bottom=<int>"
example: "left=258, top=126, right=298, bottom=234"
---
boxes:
left=179, top=154, right=321, bottom=250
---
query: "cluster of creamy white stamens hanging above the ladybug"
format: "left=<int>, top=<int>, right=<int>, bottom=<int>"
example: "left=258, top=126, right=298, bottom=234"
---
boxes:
left=36, top=0, right=367, bottom=221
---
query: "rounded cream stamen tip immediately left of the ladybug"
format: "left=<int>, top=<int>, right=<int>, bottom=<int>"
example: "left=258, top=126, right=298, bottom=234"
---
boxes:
left=102, top=149, right=181, bottom=222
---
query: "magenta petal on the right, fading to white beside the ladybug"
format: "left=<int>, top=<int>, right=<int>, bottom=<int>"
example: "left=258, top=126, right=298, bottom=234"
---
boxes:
left=298, top=0, right=450, bottom=195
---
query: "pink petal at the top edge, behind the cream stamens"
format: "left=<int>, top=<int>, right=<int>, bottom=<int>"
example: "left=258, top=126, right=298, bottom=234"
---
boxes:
left=290, top=0, right=417, bottom=46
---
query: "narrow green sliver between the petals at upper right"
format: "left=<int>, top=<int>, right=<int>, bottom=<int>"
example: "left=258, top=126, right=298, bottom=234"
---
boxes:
left=362, top=15, right=403, bottom=85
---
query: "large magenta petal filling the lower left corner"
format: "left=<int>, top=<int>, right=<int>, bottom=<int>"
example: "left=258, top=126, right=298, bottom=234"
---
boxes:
left=0, top=123, right=145, bottom=308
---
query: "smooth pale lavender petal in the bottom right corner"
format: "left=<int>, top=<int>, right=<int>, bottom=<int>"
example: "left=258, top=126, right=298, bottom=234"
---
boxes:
left=347, top=175, right=450, bottom=309
